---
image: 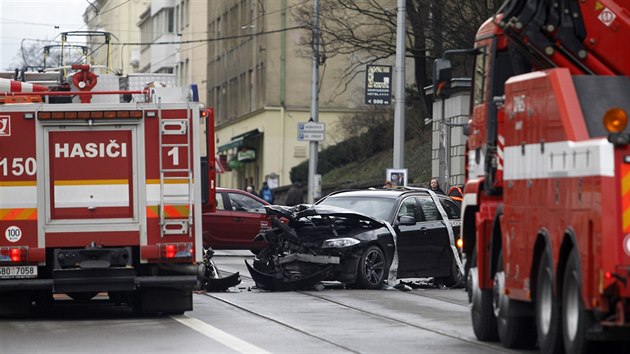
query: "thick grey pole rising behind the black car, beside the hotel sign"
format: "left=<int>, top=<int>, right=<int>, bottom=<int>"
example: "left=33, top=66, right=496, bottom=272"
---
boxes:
left=393, top=0, right=407, bottom=168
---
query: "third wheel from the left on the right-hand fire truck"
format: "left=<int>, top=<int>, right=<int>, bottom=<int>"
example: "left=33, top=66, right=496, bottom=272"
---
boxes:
left=536, top=248, right=562, bottom=353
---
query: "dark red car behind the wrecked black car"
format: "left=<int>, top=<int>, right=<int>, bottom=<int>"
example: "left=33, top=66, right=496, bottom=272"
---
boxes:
left=203, top=188, right=271, bottom=252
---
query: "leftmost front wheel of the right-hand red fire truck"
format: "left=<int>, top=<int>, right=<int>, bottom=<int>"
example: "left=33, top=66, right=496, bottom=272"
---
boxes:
left=466, top=251, right=498, bottom=342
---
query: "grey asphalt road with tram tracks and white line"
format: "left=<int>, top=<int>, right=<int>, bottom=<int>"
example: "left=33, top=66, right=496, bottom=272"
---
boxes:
left=0, top=252, right=532, bottom=353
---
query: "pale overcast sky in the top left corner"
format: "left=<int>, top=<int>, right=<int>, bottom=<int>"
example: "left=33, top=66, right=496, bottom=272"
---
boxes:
left=0, top=0, right=90, bottom=70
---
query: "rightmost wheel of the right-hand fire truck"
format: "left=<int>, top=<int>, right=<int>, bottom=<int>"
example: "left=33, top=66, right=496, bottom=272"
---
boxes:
left=562, top=248, right=593, bottom=353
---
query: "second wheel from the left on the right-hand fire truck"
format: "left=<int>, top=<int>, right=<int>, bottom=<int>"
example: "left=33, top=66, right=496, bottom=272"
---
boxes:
left=492, top=251, right=536, bottom=348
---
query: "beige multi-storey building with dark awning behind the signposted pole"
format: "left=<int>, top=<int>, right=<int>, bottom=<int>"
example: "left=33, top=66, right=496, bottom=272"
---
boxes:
left=207, top=0, right=364, bottom=189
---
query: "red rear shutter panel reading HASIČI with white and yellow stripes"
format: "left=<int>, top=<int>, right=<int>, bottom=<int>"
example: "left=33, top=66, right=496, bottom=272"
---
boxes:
left=44, top=125, right=139, bottom=224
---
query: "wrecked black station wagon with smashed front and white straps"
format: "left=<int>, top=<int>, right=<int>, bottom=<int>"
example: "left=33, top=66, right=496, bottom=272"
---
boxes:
left=247, top=188, right=463, bottom=290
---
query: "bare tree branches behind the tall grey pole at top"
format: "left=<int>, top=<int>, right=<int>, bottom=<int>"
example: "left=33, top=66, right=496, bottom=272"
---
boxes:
left=293, top=0, right=498, bottom=117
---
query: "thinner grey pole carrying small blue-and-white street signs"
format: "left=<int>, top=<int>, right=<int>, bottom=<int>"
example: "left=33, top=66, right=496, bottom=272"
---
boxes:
left=307, top=0, right=319, bottom=204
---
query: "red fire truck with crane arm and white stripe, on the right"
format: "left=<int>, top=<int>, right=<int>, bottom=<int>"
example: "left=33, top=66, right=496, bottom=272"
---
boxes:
left=434, top=0, right=630, bottom=353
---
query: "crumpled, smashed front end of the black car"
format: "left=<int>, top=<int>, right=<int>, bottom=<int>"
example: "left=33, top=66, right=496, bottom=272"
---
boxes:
left=245, top=204, right=386, bottom=291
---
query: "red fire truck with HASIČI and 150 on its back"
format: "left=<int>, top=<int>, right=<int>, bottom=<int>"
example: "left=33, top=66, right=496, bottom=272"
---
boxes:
left=0, top=64, right=214, bottom=315
